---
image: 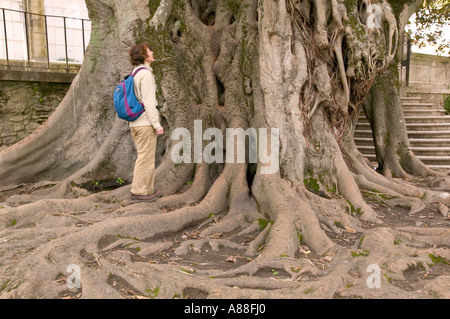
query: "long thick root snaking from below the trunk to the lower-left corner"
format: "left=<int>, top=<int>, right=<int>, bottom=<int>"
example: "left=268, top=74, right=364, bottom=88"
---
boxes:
left=2, top=166, right=230, bottom=297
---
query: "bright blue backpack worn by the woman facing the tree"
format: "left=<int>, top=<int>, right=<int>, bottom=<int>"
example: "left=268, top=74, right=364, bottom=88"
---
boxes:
left=114, top=68, right=145, bottom=122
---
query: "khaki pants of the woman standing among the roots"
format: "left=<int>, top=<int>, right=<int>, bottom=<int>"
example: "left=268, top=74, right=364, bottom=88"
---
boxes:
left=130, top=126, right=157, bottom=195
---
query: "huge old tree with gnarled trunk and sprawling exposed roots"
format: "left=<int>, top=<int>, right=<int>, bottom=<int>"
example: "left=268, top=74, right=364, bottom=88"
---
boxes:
left=0, top=0, right=450, bottom=298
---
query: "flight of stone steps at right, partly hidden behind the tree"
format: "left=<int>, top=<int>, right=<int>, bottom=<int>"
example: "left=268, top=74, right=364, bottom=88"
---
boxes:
left=355, top=97, right=450, bottom=169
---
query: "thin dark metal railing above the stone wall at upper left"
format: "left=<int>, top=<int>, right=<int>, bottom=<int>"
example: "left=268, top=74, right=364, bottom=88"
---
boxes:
left=0, top=8, right=90, bottom=72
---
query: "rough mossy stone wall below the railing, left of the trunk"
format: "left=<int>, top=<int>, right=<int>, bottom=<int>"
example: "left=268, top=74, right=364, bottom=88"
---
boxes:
left=0, top=81, right=70, bottom=150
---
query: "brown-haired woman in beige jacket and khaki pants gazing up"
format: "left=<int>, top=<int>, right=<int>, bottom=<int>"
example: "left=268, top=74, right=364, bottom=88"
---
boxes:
left=129, top=43, right=164, bottom=202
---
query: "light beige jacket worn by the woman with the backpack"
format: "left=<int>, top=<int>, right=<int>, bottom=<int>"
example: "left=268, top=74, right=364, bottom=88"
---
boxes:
left=130, top=64, right=161, bottom=130
